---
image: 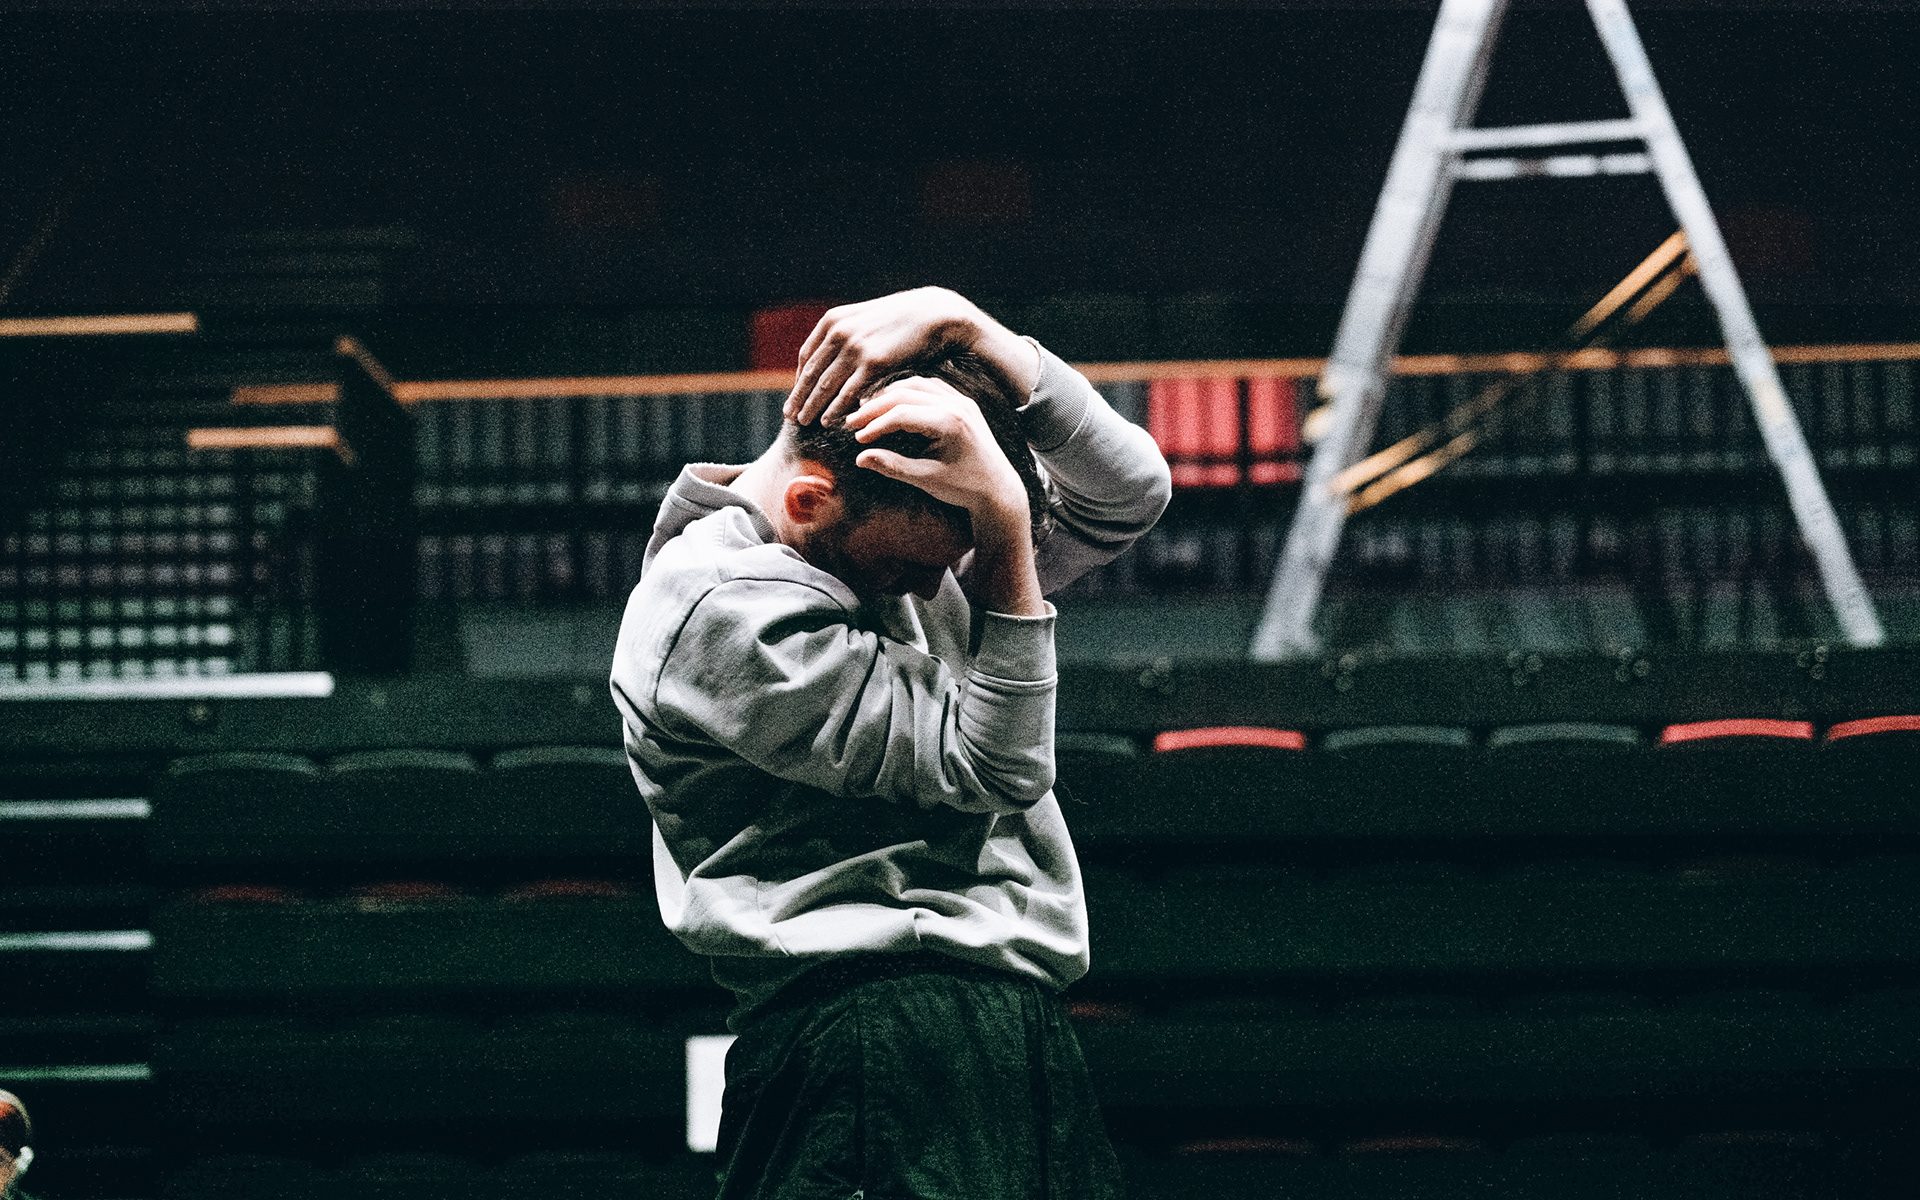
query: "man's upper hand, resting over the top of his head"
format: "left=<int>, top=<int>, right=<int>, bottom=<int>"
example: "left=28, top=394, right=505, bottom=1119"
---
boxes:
left=783, top=288, right=1041, bottom=424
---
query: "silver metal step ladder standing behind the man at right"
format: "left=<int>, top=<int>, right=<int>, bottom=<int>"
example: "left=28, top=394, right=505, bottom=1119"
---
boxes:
left=1252, top=0, right=1885, bottom=660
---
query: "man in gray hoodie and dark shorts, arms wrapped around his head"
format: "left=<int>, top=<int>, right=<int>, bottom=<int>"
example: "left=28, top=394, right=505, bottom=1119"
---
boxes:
left=612, top=288, right=1171, bottom=1200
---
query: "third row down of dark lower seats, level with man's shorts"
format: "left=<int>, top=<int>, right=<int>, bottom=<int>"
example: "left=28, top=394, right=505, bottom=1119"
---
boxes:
left=154, top=987, right=1920, bottom=1135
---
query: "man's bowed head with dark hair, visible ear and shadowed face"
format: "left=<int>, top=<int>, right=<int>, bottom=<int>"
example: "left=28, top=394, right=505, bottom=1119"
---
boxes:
left=781, top=353, right=1048, bottom=599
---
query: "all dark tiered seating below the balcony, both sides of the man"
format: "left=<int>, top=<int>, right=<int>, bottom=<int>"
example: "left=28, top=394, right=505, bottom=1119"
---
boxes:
left=0, top=668, right=1920, bottom=1200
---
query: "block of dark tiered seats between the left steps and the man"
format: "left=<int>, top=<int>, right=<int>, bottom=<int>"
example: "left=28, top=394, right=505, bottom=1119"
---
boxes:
left=152, top=729, right=724, bottom=1198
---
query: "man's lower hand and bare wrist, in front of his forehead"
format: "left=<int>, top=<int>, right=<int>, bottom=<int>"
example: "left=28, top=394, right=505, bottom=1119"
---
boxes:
left=847, top=376, right=1027, bottom=524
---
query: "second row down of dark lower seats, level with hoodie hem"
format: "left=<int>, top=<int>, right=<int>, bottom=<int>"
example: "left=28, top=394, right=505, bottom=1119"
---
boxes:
left=152, top=854, right=1920, bottom=996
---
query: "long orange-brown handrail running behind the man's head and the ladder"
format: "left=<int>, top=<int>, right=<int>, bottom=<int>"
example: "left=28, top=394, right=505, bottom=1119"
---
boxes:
left=232, top=342, right=1920, bottom=405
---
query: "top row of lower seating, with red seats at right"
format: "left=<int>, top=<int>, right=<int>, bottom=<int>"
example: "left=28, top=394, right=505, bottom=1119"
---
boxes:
left=150, top=716, right=1920, bottom=864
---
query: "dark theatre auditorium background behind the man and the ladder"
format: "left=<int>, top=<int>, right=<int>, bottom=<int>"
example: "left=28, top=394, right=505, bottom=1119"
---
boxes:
left=0, top=0, right=1920, bottom=1200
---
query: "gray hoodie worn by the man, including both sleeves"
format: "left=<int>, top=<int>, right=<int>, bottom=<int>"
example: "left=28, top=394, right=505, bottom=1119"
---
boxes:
left=612, top=339, right=1171, bottom=1029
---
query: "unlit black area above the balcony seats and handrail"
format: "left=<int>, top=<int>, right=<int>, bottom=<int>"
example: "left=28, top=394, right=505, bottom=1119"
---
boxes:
left=0, top=2, right=1920, bottom=355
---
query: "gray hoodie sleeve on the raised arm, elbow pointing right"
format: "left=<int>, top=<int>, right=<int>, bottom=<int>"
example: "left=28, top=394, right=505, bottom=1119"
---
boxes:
left=1018, top=338, right=1173, bottom=593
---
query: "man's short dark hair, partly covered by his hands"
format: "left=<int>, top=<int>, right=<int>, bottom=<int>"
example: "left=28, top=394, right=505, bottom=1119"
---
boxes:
left=783, top=349, right=1052, bottom=545
